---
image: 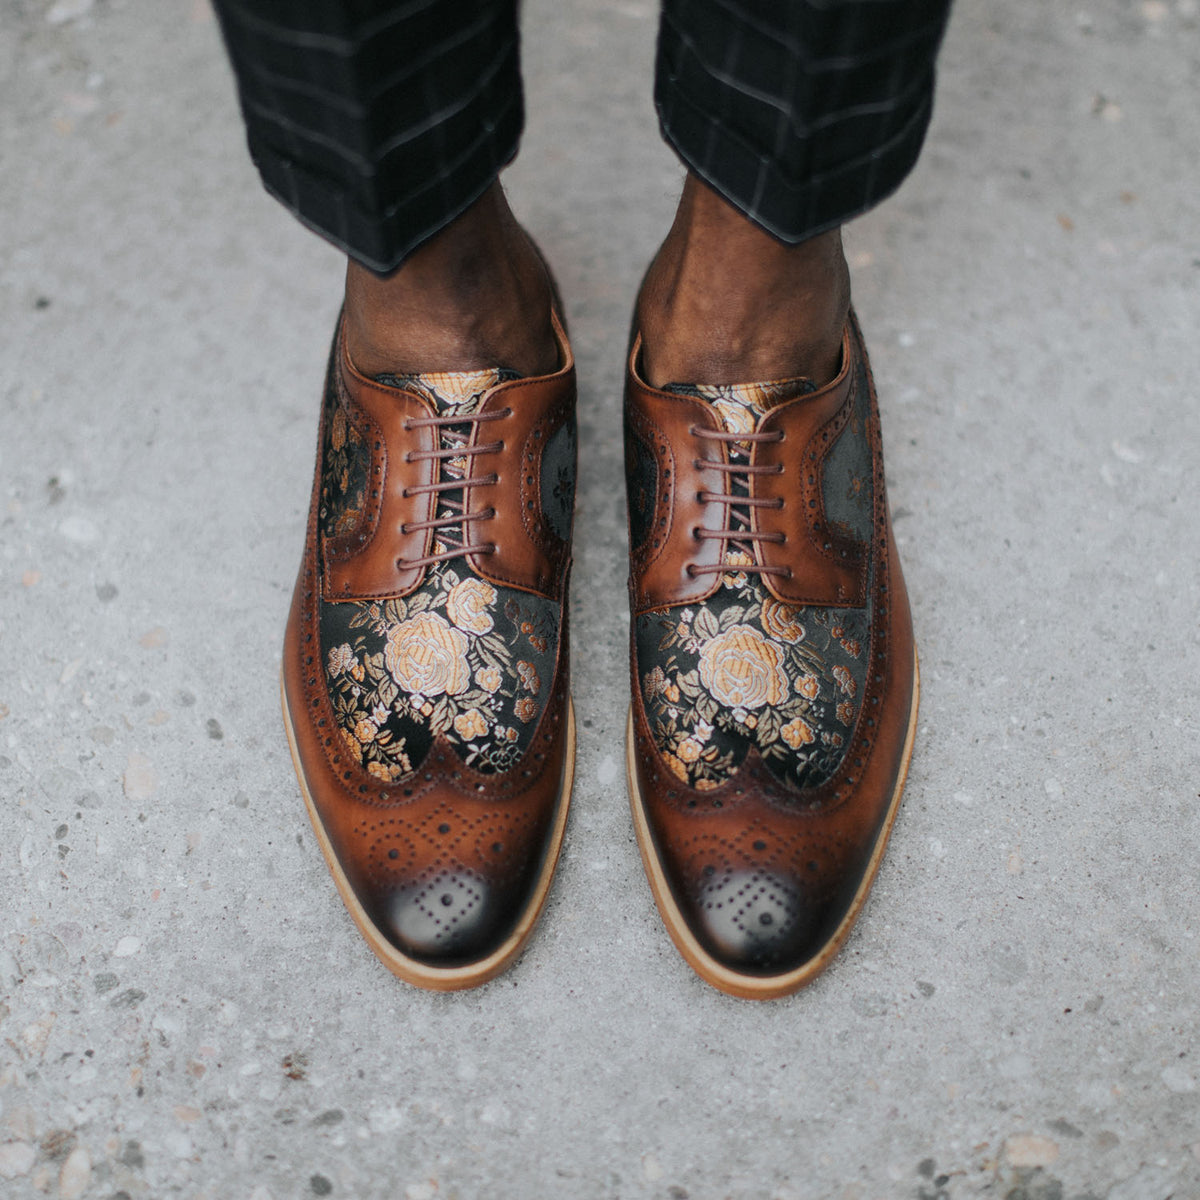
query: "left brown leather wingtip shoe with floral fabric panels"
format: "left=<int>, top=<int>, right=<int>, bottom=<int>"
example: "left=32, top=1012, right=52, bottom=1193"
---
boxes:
left=282, top=318, right=576, bottom=990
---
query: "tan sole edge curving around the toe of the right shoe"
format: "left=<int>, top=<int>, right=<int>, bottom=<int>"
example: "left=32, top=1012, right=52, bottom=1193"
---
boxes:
left=625, top=649, right=920, bottom=1000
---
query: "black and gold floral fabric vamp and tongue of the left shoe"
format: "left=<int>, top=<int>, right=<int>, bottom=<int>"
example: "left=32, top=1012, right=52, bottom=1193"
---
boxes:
left=320, top=371, right=559, bottom=781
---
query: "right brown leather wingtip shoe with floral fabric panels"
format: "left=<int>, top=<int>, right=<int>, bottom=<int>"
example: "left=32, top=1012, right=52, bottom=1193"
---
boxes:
left=625, top=314, right=918, bottom=998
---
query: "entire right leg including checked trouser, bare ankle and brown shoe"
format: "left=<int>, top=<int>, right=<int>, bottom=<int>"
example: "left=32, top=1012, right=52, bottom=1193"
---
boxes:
left=625, top=0, right=946, bottom=998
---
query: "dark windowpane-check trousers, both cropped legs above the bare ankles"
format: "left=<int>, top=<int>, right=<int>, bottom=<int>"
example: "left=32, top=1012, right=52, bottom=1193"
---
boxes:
left=216, top=0, right=950, bottom=271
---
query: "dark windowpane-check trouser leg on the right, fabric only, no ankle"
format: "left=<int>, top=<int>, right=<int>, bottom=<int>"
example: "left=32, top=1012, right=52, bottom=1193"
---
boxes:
left=654, top=0, right=950, bottom=242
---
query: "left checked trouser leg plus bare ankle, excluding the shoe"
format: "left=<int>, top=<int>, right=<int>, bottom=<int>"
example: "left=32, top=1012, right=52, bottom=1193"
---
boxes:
left=217, top=0, right=557, bottom=374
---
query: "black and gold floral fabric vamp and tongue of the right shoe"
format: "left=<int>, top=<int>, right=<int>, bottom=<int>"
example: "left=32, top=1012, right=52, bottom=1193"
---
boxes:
left=636, top=369, right=870, bottom=791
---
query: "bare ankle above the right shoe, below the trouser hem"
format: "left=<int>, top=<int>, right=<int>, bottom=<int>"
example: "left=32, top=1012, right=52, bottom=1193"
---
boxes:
left=637, top=175, right=850, bottom=386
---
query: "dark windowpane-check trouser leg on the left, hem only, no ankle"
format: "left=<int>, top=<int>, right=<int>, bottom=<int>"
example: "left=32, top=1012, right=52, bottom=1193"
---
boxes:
left=215, top=0, right=524, bottom=271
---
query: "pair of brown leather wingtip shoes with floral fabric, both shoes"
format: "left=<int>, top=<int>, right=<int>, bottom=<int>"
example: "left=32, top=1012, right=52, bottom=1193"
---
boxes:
left=283, top=285, right=918, bottom=998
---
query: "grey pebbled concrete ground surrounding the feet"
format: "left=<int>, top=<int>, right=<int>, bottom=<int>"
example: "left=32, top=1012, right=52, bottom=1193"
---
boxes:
left=0, top=0, right=1200, bottom=1200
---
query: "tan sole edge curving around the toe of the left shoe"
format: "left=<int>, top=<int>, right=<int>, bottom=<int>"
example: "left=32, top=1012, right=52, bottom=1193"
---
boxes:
left=280, top=673, right=575, bottom=991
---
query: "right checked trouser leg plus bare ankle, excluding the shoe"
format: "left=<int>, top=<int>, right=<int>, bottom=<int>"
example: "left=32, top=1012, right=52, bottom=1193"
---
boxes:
left=638, top=0, right=949, bottom=384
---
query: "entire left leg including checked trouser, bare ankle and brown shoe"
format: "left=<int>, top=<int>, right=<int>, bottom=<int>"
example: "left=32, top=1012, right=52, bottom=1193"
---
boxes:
left=220, top=0, right=575, bottom=989
